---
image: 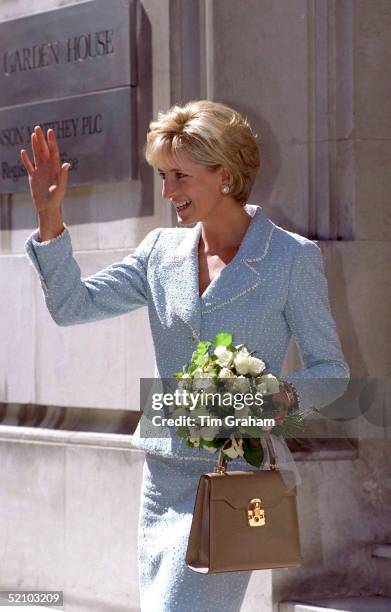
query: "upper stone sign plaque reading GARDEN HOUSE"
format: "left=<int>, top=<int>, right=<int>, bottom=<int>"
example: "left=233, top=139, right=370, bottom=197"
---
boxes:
left=0, top=0, right=136, bottom=108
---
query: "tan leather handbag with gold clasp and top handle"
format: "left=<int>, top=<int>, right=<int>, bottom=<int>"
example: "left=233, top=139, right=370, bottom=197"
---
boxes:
left=186, top=437, right=302, bottom=574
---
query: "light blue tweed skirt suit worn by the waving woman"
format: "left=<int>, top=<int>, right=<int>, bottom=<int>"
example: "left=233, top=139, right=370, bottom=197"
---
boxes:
left=25, top=204, right=349, bottom=612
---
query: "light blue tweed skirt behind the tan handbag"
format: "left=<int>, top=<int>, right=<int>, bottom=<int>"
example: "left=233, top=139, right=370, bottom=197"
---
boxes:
left=138, top=453, right=253, bottom=612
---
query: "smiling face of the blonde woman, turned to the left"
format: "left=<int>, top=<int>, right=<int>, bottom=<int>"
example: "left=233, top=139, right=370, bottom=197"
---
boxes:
left=158, top=154, right=228, bottom=226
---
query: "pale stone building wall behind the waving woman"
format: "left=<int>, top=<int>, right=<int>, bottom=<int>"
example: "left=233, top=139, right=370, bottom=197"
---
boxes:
left=0, top=0, right=391, bottom=612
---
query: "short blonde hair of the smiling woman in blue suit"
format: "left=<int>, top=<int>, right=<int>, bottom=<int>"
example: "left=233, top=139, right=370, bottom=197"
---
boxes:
left=145, top=100, right=260, bottom=204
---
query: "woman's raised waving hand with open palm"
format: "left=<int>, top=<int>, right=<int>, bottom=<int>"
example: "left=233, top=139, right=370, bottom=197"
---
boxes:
left=20, top=126, right=70, bottom=213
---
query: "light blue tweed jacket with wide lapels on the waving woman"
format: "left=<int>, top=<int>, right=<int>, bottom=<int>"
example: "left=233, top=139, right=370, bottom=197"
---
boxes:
left=25, top=204, right=349, bottom=460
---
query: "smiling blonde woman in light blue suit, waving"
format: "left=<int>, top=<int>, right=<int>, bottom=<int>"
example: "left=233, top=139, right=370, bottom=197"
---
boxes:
left=21, top=101, right=349, bottom=612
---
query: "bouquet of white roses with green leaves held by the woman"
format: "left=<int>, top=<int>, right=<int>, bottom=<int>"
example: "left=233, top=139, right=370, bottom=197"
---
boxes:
left=171, top=332, right=302, bottom=467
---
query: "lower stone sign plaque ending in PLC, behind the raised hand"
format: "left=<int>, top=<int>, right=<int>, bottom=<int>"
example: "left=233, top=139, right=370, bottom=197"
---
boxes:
left=0, top=87, right=137, bottom=193
